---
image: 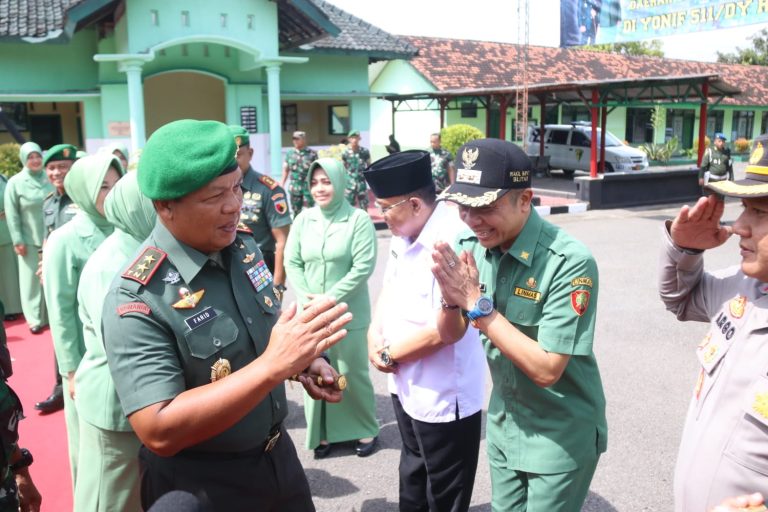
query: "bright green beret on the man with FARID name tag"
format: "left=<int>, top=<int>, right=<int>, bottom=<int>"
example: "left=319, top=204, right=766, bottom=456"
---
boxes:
left=138, top=119, right=237, bottom=200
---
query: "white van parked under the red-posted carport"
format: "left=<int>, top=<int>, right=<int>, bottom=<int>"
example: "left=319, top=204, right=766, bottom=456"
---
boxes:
left=527, top=123, right=648, bottom=176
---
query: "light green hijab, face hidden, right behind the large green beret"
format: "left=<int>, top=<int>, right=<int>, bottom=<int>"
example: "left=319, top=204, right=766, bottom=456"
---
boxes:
left=104, top=172, right=157, bottom=242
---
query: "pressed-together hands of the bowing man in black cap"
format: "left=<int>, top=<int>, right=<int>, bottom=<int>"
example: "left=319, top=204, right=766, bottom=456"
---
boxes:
left=432, top=242, right=482, bottom=311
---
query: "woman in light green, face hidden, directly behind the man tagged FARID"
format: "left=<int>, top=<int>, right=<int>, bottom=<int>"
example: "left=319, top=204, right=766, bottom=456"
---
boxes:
left=73, top=172, right=152, bottom=512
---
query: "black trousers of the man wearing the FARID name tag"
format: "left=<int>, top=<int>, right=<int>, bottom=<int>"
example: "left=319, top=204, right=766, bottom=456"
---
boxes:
left=139, top=429, right=315, bottom=512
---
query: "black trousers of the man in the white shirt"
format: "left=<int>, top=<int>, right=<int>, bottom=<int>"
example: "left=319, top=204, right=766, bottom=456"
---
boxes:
left=392, top=395, right=482, bottom=512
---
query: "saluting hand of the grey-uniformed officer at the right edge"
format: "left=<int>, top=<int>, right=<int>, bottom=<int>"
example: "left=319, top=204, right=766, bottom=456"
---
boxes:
left=669, top=195, right=732, bottom=250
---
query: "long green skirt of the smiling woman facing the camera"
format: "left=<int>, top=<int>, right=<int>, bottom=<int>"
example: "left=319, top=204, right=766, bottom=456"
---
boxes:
left=304, top=329, right=379, bottom=450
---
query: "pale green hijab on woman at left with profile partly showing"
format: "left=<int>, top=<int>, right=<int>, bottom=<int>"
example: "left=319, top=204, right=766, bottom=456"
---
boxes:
left=64, top=153, right=123, bottom=229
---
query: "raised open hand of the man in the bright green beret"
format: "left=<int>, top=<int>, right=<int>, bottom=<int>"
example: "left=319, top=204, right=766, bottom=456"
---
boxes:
left=262, top=296, right=352, bottom=380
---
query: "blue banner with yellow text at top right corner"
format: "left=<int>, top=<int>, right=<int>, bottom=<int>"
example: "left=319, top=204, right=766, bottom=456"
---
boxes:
left=560, top=0, right=768, bottom=47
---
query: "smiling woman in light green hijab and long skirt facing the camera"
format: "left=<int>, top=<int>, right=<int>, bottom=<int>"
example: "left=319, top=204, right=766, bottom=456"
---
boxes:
left=285, top=158, right=379, bottom=458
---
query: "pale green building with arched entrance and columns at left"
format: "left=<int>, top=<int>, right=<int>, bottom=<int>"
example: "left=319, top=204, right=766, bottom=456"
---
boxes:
left=0, top=0, right=415, bottom=174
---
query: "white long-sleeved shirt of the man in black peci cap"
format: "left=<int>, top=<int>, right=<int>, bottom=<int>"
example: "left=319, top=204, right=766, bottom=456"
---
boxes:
left=379, top=202, right=487, bottom=423
